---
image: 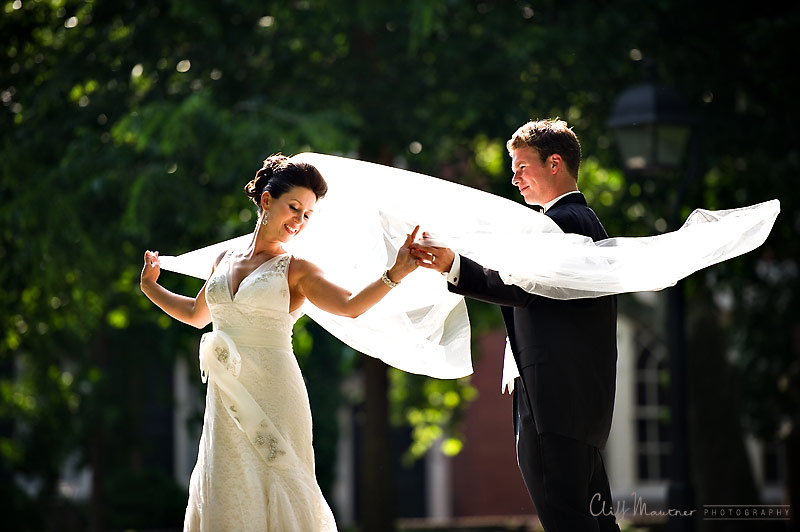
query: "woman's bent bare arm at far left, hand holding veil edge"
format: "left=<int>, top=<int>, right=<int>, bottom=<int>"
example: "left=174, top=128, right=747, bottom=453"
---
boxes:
left=139, top=251, right=222, bottom=329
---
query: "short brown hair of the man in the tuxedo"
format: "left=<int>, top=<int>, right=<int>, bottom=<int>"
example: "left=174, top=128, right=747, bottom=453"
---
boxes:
left=506, top=118, right=581, bottom=180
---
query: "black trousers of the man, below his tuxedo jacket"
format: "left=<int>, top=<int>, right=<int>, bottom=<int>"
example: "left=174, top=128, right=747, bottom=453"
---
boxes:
left=514, top=383, right=619, bottom=532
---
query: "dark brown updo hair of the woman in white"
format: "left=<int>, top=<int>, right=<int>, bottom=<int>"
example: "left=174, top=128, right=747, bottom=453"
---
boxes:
left=244, top=153, right=328, bottom=213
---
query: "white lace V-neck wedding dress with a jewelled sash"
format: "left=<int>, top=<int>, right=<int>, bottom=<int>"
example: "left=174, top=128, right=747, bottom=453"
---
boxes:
left=184, top=252, right=336, bottom=532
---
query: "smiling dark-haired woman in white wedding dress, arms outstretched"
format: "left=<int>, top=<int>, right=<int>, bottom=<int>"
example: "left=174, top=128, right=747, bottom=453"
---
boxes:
left=141, top=155, right=418, bottom=531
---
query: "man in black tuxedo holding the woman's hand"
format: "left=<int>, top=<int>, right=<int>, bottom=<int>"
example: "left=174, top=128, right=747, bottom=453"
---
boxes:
left=412, top=120, right=619, bottom=532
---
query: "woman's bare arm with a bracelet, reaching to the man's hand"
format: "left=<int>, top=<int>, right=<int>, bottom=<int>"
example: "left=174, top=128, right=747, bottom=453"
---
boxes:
left=292, top=226, right=419, bottom=318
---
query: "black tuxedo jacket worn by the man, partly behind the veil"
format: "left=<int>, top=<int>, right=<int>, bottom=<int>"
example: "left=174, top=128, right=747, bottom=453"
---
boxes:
left=448, top=193, right=617, bottom=449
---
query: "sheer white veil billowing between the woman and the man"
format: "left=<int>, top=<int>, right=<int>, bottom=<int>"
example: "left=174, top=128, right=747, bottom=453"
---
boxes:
left=161, top=153, right=780, bottom=378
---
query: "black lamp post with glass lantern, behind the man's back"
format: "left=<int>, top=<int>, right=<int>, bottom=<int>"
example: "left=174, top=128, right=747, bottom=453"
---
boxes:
left=608, top=65, right=698, bottom=532
